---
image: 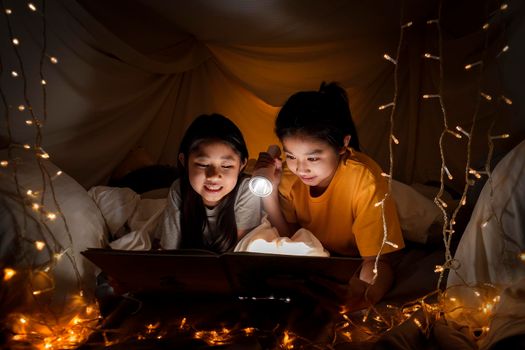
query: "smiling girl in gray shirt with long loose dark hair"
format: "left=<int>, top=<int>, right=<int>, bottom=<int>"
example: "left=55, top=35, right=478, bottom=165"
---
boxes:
left=156, top=114, right=261, bottom=253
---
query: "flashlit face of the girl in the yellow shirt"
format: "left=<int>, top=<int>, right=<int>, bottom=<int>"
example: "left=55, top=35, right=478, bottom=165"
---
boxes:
left=282, top=135, right=340, bottom=191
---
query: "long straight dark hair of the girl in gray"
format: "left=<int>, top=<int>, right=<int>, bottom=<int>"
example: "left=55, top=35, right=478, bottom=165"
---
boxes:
left=177, top=114, right=248, bottom=253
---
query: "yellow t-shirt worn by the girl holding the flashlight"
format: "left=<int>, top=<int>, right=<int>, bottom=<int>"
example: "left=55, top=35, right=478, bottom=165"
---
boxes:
left=279, top=149, right=404, bottom=257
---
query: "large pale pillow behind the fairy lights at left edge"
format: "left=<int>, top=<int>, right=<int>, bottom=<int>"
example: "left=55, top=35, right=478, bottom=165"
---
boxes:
left=0, top=148, right=106, bottom=309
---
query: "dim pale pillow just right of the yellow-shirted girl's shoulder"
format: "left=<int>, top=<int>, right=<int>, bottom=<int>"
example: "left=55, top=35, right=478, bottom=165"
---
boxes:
left=392, top=180, right=443, bottom=243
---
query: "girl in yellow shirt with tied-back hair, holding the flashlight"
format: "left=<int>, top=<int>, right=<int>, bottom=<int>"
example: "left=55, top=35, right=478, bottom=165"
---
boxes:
left=256, top=83, right=404, bottom=309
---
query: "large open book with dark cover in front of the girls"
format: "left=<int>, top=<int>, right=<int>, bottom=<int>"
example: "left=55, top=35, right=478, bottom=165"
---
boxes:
left=82, top=248, right=362, bottom=296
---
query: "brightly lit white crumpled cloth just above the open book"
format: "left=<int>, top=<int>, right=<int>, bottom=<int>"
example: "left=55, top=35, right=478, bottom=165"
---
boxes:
left=234, top=216, right=330, bottom=256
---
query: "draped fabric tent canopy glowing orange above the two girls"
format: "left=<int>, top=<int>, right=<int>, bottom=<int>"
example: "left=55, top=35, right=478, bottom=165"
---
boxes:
left=0, top=0, right=525, bottom=190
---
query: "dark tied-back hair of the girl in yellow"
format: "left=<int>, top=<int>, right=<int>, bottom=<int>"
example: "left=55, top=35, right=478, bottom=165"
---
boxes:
left=274, top=82, right=360, bottom=152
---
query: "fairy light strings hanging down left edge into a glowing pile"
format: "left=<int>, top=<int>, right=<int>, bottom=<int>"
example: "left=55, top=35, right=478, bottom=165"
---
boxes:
left=0, top=0, right=99, bottom=348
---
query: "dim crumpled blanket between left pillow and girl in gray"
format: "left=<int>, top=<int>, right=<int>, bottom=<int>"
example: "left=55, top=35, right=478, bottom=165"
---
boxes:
left=88, top=186, right=166, bottom=250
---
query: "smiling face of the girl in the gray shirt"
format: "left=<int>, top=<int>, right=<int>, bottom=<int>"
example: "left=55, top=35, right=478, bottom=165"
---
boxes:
left=184, top=141, right=246, bottom=207
